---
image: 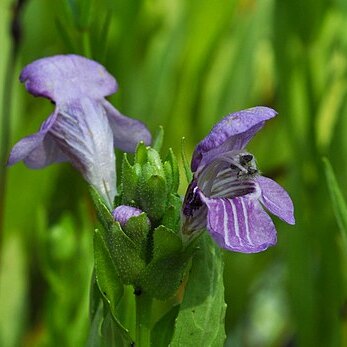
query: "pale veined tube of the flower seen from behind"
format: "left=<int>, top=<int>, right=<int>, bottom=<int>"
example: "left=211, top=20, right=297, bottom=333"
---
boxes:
left=50, top=98, right=116, bottom=206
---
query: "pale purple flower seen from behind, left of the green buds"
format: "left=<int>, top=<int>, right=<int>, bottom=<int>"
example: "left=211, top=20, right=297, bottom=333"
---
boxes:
left=8, top=55, right=151, bottom=206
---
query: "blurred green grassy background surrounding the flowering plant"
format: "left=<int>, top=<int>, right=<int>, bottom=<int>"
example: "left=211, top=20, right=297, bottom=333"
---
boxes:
left=0, top=0, right=347, bottom=347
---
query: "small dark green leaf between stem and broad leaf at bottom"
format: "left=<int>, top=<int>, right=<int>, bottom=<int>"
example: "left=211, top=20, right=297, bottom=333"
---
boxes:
left=151, top=305, right=179, bottom=347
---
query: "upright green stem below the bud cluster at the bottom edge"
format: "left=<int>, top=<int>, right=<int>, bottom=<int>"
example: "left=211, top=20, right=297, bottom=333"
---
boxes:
left=136, top=293, right=152, bottom=347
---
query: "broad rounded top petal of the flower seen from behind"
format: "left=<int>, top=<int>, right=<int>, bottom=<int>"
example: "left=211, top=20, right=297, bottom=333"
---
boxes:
left=19, top=54, right=117, bottom=103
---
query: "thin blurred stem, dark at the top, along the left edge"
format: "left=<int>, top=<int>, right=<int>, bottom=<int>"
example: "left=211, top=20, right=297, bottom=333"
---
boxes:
left=0, top=0, right=26, bottom=245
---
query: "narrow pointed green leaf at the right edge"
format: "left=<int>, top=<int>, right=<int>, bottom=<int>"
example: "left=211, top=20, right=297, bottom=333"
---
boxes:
left=323, top=158, right=347, bottom=245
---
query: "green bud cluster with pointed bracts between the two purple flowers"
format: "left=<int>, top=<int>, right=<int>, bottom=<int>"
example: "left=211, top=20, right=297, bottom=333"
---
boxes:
left=92, top=143, right=194, bottom=300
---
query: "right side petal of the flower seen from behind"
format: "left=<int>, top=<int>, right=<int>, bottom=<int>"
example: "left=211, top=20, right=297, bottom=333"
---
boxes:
left=102, top=100, right=152, bottom=152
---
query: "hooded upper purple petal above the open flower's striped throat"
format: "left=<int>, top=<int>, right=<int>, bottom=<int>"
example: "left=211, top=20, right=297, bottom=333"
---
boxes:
left=191, top=106, right=277, bottom=172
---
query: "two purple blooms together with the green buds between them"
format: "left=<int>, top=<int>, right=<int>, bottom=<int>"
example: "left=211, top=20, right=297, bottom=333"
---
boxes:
left=8, top=55, right=295, bottom=253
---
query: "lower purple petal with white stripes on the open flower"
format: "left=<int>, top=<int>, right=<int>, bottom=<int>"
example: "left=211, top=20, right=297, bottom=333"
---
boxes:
left=202, top=197, right=277, bottom=253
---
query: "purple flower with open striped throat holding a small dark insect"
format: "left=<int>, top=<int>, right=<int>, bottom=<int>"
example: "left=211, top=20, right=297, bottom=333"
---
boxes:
left=183, top=107, right=295, bottom=253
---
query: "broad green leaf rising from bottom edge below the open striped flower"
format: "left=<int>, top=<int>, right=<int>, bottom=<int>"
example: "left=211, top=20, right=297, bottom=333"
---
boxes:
left=170, top=233, right=226, bottom=347
